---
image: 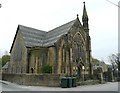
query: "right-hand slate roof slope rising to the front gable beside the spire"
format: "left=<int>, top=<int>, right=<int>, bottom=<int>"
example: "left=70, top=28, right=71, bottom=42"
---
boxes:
left=43, top=20, right=75, bottom=46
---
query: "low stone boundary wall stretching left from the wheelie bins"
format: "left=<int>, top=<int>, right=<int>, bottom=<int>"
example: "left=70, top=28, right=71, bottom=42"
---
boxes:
left=2, top=73, right=60, bottom=87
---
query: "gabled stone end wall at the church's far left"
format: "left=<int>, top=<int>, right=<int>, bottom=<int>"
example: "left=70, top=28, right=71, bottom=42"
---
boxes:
left=8, top=32, right=27, bottom=73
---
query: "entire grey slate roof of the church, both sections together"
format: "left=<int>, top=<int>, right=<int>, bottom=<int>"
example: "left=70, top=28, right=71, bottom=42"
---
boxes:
left=10, top=19, right=77, bottom=52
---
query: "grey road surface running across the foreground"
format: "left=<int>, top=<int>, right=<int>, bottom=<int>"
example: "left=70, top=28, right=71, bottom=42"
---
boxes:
left=0, top=80, right=118, bottom=91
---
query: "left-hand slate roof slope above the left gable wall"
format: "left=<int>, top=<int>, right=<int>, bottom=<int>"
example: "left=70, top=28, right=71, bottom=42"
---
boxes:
left=19, top=25, right=46, bottom=47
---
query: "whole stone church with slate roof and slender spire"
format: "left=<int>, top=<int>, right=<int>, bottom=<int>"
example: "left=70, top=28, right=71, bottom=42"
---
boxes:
left=8, top=3, right=92, bottom=76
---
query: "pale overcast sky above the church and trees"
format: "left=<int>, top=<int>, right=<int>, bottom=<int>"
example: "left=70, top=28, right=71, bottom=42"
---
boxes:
left=0, top=0, right=119, bottom=61
